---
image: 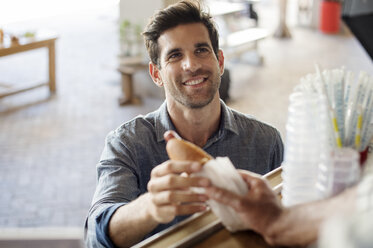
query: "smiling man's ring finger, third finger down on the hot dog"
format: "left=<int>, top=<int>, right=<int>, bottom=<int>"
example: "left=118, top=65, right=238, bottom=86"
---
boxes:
left=152, top=191, right=208, bottom=205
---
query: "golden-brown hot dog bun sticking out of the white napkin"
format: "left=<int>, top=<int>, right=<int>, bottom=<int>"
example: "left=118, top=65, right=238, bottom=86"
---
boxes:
left=166, top=137, right=213, bottom=164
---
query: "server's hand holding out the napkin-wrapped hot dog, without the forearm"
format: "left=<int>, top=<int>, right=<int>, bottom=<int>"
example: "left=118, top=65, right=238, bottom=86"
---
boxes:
left=206, top=171, right=283, bottom=238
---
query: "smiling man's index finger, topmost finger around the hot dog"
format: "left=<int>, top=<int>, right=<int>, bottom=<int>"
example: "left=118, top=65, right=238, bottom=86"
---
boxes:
left=151, top=160, right=202, bottom=177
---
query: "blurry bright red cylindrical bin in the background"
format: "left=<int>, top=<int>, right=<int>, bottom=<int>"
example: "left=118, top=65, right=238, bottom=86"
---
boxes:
left=320, top=1, right=341, bottom=33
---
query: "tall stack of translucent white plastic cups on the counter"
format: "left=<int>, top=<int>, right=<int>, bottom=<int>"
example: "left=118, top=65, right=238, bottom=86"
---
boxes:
left=282, top=92, right=329, bottom=206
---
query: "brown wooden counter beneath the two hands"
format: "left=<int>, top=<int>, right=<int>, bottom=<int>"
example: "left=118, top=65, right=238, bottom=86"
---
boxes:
left=134, top=167, right=282, bottom=248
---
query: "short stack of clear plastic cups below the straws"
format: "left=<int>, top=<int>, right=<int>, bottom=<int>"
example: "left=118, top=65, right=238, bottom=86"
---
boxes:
left=316, top=147, right=360, bottom=198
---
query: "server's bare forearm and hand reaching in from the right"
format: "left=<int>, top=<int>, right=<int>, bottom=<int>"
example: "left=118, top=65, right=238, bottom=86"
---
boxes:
left=206, top=172, right=357, bottom=245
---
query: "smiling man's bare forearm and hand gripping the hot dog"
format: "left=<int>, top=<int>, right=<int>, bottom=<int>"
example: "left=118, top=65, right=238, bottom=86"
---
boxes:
left=108, top=160, right=210, bottom=247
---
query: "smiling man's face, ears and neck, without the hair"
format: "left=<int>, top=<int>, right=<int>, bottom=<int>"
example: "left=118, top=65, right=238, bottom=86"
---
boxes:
left=149, top=23, right=224, bottom=147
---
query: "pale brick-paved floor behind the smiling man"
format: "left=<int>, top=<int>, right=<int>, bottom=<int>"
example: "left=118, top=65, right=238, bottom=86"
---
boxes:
left=0, top=1, right=373, bottom=231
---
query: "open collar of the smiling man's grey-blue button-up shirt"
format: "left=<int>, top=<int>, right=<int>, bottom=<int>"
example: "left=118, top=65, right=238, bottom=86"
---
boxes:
left=155, top=100, right=238, bottom=142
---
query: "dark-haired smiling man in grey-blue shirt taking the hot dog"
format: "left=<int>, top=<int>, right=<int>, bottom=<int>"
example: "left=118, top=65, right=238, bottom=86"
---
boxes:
left=86, top=1, right=283, bottom=247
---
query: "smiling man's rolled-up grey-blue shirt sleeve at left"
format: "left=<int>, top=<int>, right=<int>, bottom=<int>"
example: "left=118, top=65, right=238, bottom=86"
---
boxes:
left=85, top=131, right=141, bottom=248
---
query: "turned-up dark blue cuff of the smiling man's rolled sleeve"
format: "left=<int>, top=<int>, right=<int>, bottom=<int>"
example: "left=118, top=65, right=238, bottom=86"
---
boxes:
left=96, top=203, right=124, bottom=248
